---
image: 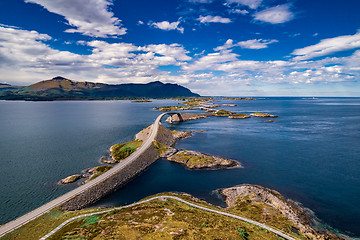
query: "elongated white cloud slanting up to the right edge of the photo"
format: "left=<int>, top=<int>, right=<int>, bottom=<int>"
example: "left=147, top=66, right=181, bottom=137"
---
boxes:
left=292, top=31, right=360, bottom=60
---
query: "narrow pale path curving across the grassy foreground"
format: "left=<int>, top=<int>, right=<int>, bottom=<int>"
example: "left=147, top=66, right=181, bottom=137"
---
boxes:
left=40, top=196, right=296, bottom=240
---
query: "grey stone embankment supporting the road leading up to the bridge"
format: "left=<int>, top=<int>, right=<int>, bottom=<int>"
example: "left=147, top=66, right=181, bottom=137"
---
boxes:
left=60, top=125, right=175, bottom=211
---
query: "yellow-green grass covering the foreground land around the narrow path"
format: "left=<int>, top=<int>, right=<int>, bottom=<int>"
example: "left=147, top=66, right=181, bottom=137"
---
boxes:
left=3, top=193, right=304, bottom=240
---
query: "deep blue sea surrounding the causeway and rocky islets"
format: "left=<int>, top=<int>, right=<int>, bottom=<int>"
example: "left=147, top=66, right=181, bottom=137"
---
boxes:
left=0, top=97, right=360, bottom=237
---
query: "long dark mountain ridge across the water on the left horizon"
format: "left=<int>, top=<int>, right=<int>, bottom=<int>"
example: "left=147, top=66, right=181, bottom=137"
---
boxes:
left=0, top=76, right=199, bottom=101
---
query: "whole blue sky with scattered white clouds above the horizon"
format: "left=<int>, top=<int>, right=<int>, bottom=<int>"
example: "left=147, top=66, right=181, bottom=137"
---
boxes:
left=0, top=0, right=360, bottom=97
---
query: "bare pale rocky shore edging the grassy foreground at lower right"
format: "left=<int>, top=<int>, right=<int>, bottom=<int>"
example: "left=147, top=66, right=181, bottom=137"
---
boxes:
left=221, top=184, right=342, bottom=240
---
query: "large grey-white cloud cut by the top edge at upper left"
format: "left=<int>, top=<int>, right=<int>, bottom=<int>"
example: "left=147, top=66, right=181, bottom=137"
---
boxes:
left=25, top=0, right=127, bottom=38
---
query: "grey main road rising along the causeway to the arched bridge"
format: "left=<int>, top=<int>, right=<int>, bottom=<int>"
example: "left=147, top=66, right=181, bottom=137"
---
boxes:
left=0, top=113, right=167, bottom=237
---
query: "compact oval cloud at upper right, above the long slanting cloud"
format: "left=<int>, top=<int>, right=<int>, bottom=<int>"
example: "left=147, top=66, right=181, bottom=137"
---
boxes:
left=254, top=4, right=294, bottom=24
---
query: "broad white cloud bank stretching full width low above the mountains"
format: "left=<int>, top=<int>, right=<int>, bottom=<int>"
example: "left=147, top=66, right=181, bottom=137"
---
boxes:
left=0, top=26, right=360, bottom=95
